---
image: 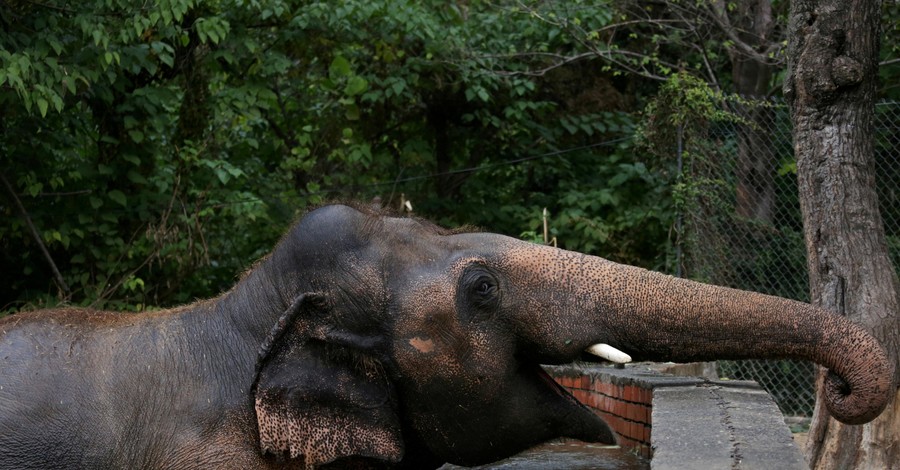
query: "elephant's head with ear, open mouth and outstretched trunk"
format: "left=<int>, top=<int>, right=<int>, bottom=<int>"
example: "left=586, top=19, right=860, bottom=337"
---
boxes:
left=254, top=205, right=895, bottom=466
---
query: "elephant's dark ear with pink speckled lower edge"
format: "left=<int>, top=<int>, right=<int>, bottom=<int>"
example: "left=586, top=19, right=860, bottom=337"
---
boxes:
left=253, top=294, right=403, bottom=468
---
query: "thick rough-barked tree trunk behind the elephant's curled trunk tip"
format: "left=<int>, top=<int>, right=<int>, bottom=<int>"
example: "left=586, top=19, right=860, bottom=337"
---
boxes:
left=784, top=0, right=900, bottom=469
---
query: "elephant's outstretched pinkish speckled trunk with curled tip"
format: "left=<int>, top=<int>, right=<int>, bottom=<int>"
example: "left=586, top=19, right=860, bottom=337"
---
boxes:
left=510, top=248, right=896, bottom=424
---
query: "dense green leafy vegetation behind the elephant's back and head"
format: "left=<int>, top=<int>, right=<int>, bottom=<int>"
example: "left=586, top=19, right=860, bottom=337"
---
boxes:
left=0, top=0, right=897, bottom=312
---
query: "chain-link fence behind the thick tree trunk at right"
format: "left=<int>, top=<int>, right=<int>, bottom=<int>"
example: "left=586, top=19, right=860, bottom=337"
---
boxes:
left=677, top=100, right=900, bottom=416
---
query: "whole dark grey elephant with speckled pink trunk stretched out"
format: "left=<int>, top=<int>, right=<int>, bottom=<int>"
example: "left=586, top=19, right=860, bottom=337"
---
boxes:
left=0, top=204, right=897, bottom=469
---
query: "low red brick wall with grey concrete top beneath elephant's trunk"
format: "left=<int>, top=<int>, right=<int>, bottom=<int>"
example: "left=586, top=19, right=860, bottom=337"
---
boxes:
left=546, top=364, right=808, bottom=470
